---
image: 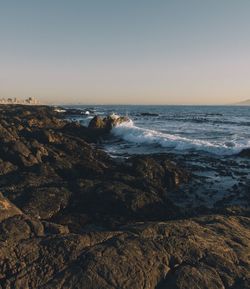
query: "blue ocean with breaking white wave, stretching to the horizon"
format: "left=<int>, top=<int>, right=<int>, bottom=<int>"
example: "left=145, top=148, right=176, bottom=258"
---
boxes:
left=65, top=105, right=250, bottom=156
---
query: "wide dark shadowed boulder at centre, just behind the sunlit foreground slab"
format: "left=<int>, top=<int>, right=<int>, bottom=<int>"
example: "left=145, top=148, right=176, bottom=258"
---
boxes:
left=71, top=181, right=177, bottom=227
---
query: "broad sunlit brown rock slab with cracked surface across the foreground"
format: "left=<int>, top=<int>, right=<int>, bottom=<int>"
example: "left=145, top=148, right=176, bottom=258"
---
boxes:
left=0, top=216, right=247, bottom=289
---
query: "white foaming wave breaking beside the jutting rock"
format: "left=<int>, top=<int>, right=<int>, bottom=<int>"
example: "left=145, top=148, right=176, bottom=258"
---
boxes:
left=112, top=120, right=250, bottom=155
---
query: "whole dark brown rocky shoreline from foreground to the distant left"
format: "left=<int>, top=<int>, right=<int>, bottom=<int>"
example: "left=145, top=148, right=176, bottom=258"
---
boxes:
left=0, top=105, right=250, bottom=289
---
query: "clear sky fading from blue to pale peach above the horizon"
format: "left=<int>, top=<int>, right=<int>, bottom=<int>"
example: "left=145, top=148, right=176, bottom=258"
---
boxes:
left=0, top=0, right=250, bottom=104
